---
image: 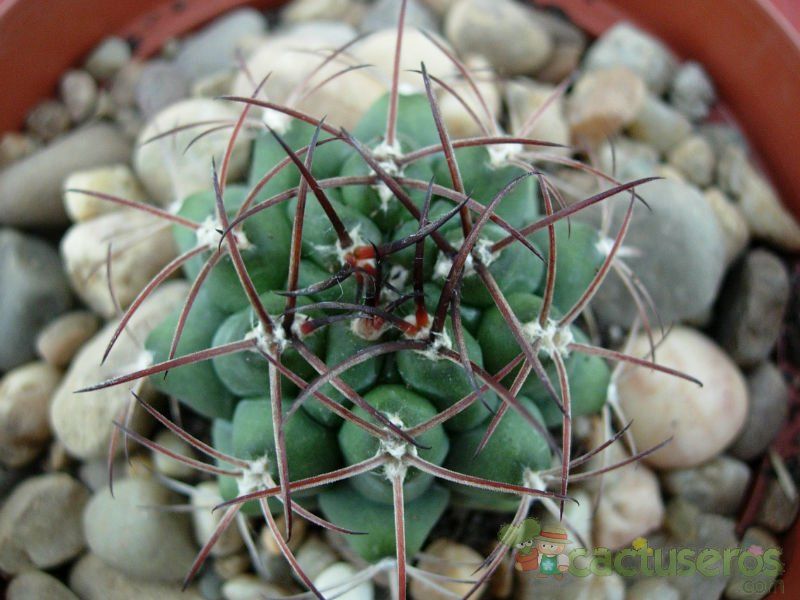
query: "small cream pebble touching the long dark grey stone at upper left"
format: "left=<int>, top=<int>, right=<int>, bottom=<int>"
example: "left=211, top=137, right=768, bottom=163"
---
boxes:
left=64, top=164, right=147, bottom=223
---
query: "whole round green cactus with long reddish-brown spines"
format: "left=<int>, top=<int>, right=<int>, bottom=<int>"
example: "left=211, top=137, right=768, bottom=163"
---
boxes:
left=76, top=2, right=691, bottom=597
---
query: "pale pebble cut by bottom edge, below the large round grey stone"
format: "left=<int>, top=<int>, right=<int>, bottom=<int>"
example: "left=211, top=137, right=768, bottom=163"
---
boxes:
left=69, top=553, right=204, bottom=600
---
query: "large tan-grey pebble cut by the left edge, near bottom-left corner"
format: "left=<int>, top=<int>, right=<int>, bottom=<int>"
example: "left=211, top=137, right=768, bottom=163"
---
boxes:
left=0, top=473, right=89, bottom=575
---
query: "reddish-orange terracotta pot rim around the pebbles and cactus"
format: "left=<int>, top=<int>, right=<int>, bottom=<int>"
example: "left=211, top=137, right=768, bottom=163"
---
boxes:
left=0, top=0, right=800, bottom=593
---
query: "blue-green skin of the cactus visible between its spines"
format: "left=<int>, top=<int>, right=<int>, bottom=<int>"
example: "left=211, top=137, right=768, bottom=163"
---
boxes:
left=147, top=95, right=608, bottom=561
